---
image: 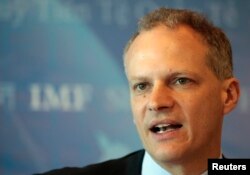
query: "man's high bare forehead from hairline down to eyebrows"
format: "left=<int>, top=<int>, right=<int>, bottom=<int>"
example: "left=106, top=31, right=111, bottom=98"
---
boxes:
left=125, top=26, right=211, bottom=78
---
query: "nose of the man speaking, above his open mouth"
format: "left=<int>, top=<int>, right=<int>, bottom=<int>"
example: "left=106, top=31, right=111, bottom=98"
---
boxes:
left=147, top=83, right=174, bottom=111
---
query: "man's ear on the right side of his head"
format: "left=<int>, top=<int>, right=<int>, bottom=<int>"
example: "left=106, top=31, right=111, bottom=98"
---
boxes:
left=223, top=78, right=240, bottom=114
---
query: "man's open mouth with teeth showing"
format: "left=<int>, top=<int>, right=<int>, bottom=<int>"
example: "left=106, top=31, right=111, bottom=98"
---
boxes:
left=150, top=124, right=182, bottom=134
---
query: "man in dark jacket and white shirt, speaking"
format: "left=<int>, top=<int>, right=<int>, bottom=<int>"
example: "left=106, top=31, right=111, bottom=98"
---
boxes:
left=37, top=8, right=240, bottom=175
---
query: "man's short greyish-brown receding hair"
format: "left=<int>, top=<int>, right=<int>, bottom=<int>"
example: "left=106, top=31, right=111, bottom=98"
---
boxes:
left=124, top=7, right=233, bottom=80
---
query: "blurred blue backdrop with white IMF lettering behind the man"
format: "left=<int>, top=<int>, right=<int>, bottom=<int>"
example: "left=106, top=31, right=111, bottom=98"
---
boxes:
left=0, top=0, right=250, bottom=175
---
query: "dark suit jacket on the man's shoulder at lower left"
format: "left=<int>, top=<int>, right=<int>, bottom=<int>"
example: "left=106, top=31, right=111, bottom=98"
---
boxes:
left=38, top=150, right=145, bottom=175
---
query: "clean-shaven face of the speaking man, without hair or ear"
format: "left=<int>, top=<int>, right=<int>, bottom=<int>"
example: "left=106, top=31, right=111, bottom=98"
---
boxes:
left=125, top=26, right=228, bottom=165
